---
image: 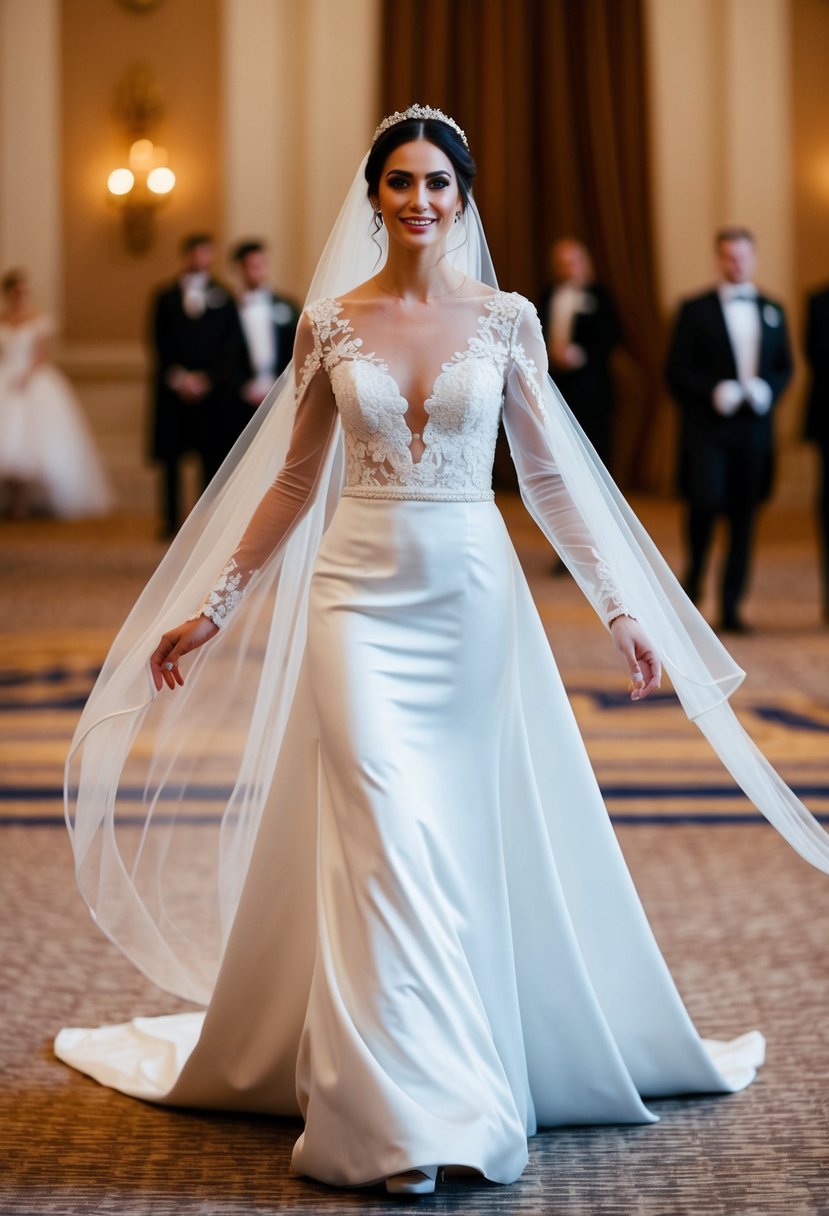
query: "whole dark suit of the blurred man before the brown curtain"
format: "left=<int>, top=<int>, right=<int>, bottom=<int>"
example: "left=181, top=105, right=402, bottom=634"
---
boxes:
left=538, top=283, right=619, bottom=466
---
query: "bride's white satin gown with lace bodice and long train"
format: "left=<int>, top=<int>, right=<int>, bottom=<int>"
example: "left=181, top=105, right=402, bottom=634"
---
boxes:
left=56, top=293, right=763, bottom=1184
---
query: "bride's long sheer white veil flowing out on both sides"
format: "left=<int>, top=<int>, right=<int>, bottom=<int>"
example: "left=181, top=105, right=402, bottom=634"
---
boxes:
left=64, top=142, right=829, bottom=1002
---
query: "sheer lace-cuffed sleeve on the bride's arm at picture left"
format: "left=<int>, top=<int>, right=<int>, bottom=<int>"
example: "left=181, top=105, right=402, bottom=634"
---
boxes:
left=191, top=311, right=337, bottom=626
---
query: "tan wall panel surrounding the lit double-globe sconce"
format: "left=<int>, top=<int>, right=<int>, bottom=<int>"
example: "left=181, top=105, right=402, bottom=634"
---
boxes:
left=61, top=0, right=224, bottom=343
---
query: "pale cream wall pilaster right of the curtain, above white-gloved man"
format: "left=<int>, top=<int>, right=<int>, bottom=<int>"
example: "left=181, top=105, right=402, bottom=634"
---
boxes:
left=647, top=0, right=794, bottom=309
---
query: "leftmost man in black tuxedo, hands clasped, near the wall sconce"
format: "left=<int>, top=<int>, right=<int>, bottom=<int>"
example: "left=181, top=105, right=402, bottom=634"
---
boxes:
left=151, top=232, right=250, bottom=536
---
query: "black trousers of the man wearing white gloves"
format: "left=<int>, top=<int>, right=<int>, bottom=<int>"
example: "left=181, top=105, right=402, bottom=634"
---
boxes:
left=686, top=413, right=769, bottom=621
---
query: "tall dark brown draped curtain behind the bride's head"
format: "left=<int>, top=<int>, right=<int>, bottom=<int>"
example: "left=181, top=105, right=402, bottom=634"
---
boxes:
left=383, top=0, right=666, bottom=488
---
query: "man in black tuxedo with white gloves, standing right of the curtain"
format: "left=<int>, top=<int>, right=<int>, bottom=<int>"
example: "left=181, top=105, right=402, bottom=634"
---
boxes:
left=666, top=227, right=791, bottom=632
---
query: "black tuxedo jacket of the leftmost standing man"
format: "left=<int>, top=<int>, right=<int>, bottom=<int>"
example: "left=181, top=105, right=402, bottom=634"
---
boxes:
left=150, top=278, right=252, bottom=460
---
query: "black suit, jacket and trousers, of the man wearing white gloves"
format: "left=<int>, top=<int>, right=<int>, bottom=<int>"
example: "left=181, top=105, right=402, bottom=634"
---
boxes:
left=666, top=291, right=791, bottom=623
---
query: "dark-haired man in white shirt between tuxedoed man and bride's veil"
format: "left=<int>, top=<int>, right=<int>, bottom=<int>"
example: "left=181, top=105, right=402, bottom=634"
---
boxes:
left=232, top=241, right=299, bottom=433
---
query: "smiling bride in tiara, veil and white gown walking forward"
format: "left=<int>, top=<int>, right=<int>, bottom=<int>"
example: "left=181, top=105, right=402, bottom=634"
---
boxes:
left=56, top=106, right=829, bottom=1193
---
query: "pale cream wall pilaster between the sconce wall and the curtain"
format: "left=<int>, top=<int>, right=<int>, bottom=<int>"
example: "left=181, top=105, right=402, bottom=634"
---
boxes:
left=222, top=0, right=380, bottom=299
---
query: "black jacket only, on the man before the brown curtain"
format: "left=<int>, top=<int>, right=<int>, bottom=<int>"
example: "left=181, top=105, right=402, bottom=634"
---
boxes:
left=538, top=283, right=620, bottom=416
